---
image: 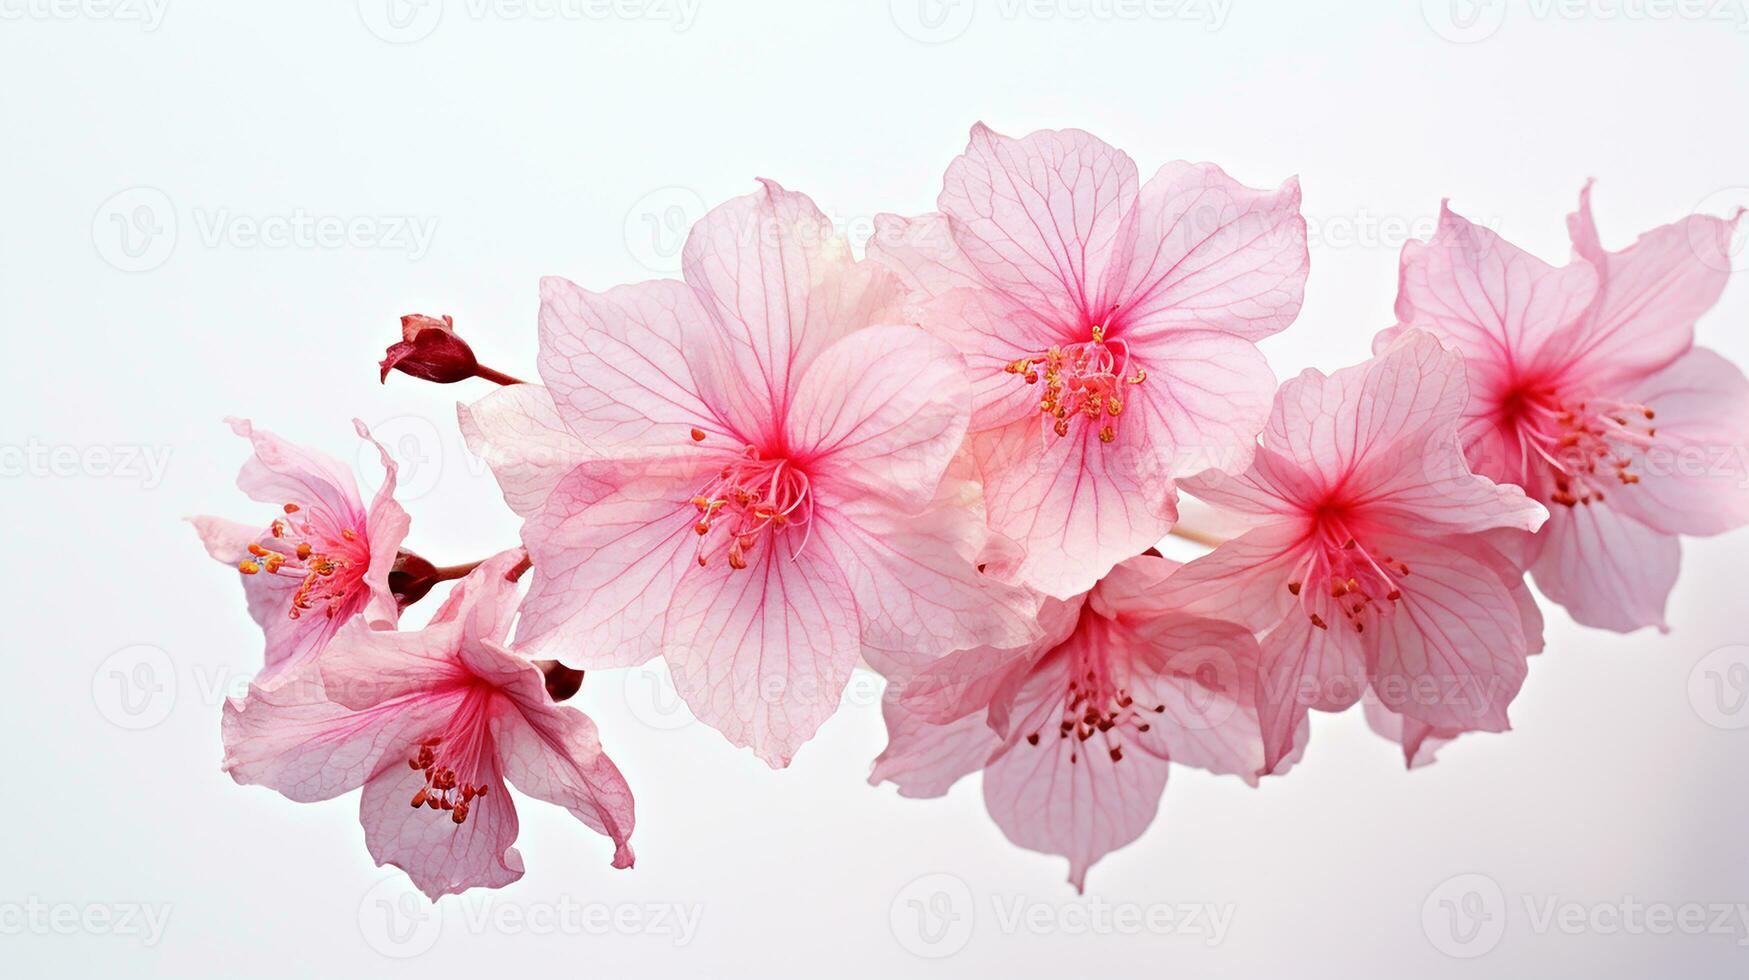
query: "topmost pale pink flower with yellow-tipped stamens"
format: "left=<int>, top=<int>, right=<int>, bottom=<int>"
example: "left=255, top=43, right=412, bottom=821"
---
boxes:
left=869, top=124, right=1308, bottom=597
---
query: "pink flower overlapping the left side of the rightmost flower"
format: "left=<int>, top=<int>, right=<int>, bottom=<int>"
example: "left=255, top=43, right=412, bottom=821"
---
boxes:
left=1165, top=331, right=1546, bottom=770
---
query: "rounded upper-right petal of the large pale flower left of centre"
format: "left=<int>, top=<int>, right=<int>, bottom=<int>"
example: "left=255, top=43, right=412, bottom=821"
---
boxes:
left=785, top=327, right=971, bottom=513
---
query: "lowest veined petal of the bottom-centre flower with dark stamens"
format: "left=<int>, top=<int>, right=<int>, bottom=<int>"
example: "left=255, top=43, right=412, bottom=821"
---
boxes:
left=985, top=658, right=1167, bottom=891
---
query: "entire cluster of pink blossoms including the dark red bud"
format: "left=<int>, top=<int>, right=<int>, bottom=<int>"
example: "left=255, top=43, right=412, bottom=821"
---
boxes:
left=194, top=126, right=1749, bottom=898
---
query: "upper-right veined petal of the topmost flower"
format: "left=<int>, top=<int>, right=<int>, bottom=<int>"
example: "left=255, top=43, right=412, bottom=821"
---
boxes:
left=1111, top=163, right=1310, bottom=345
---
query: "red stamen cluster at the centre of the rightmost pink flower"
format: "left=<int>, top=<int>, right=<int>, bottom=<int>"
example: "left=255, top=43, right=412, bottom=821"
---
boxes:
left=1518, top=399, right=1658, bottom=508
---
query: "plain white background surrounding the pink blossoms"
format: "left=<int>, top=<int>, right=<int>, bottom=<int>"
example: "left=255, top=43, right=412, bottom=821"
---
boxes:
left=0, top=0, right=1749, bottom=977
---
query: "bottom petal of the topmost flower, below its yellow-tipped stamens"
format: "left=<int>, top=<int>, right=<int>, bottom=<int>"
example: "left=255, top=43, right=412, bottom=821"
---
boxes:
left=969, top=415, right=1177, bottom=599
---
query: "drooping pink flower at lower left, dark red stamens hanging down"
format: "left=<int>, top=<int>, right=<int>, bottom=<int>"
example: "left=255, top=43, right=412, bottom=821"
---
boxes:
left=224, top=550, right=633, bottom=900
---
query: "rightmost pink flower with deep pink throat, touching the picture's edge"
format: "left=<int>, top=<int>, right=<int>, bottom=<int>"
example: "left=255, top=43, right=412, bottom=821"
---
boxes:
left=1378, top=186, right=1749, bottom=632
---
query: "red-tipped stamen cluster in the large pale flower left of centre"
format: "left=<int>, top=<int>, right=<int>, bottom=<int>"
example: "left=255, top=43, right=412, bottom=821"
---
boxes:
left=693, top=441, right=813, bottom=569
